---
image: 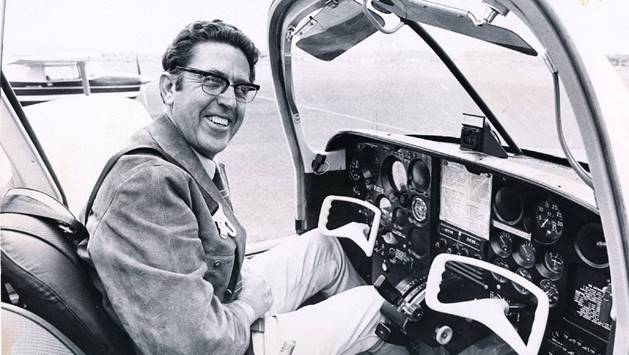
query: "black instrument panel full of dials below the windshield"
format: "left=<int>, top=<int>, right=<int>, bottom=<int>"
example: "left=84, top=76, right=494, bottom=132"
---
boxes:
left=346, top=141, right=611, bottom=354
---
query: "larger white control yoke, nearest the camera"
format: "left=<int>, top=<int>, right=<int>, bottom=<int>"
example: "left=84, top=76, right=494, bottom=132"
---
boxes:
left=426, top=254, right=549, bottom=355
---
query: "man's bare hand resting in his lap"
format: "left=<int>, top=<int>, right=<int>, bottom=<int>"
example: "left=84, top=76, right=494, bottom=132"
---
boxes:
left=237, top=262, right=273, bottom=320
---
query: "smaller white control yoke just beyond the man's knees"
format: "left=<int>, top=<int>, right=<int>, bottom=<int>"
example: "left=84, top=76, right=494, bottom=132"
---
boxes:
left=318, top=195, right=380, bottom=257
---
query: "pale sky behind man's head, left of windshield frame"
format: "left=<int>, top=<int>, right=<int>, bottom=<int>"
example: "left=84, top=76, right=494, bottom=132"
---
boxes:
left=5, top=0, right=271, bottom=54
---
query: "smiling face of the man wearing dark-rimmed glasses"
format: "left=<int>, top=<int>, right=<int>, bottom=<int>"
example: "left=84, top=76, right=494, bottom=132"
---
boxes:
left=165, top=42, right=249, bottom=158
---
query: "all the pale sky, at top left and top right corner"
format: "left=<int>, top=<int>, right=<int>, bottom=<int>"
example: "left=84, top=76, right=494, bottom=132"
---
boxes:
left=0, top=0, right=629, bottom=55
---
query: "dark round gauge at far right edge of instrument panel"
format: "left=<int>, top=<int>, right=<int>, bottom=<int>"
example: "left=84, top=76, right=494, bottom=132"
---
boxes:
left=574, top=223, right=609, bottom=269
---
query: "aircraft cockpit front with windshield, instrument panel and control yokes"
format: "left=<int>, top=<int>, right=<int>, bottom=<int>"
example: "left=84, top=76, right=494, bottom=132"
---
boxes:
left=269, top=0, right=618, bottom=354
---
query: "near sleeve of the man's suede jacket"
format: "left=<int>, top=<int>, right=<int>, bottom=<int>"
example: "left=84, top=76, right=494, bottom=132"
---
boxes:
left=88, top=165, right=253, bottom=354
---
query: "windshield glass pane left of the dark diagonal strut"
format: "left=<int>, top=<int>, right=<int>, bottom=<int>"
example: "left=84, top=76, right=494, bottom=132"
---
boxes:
left=293, top=28, right=481, bottom=149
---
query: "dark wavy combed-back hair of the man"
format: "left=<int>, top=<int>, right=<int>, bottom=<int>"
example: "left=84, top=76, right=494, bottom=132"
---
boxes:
left=162, top=20, right=260, bottom=90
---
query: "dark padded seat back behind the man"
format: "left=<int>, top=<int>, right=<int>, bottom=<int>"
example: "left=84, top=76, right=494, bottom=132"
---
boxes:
left=0, top=189, right=134, bottom=354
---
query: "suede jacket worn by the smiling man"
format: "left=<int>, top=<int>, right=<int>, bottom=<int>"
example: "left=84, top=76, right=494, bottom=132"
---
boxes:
left=79, top=116, right=253, bottom=354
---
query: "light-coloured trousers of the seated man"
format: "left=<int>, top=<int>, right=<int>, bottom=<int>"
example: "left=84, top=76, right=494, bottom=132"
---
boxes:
left=245, top=229, right=407, bottom=355
